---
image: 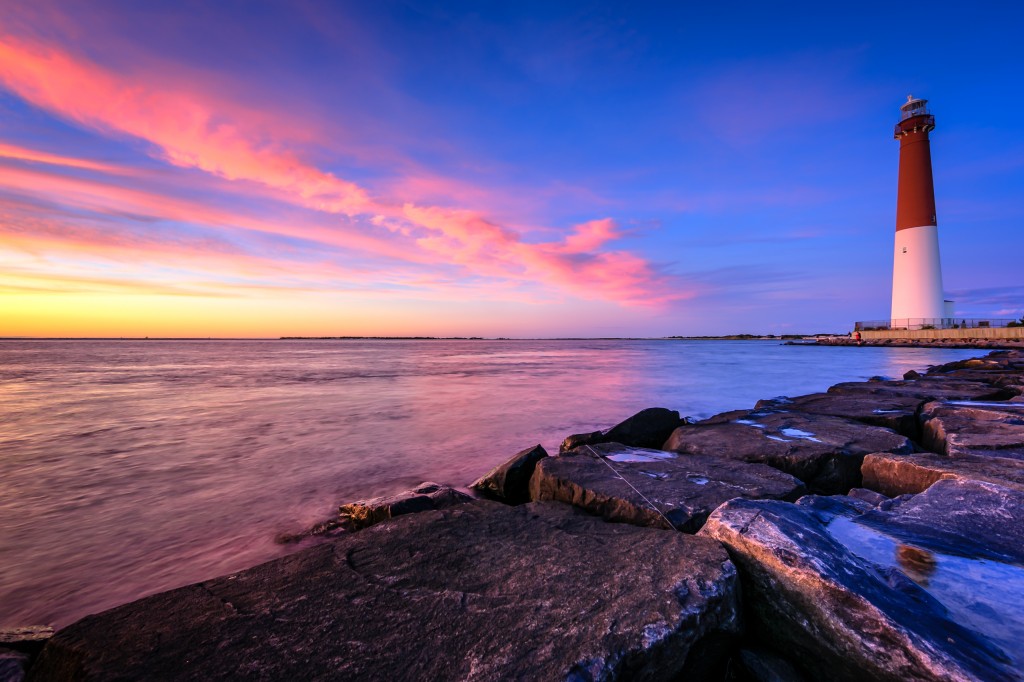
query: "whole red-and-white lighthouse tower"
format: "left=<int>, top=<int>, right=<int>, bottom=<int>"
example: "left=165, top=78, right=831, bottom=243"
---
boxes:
left=891, top=95, right=945, bottom=329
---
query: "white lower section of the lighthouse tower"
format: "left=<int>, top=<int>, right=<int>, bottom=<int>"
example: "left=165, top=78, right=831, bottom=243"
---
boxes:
left=892, top=220, right=947, bottom=327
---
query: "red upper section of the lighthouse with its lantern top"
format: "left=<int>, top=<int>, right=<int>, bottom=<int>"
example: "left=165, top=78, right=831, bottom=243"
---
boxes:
left=895, top=96, right=937, bottom=230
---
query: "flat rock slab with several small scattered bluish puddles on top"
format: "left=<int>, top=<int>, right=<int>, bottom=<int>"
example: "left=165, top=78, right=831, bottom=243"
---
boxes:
left=664, top=411, right=913, bottom=494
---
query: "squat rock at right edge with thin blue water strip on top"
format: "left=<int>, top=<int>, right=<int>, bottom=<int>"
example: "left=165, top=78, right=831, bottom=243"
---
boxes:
left=921, top=400, right=1024, bottom=460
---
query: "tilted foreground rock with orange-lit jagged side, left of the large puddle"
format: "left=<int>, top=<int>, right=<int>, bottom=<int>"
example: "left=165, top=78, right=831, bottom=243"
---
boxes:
left=698, top=493, right=1020, bottom=682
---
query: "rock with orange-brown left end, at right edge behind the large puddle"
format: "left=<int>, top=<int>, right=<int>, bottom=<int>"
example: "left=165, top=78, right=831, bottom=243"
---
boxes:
left=860, top=453, right=1024, bottom=497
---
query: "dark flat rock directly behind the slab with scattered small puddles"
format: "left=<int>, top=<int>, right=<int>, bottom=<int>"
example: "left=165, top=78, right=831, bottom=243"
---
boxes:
left=756, top=392, right=925, bottom=440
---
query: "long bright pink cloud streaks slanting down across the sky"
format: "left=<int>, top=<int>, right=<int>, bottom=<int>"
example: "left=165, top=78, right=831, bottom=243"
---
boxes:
left=0, top=37, right=688, bottom=303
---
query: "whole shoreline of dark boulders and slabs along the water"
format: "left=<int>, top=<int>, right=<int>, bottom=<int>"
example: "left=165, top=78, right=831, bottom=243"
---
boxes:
left=8, top=344, right=1024, bottom=682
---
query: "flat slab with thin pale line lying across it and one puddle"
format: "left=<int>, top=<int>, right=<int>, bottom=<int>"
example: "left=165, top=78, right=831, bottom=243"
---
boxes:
left=530, top=443, right=805, bottom=532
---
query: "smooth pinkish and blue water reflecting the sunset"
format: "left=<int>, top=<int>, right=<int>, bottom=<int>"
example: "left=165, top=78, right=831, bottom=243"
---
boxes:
left=0, top=341, right=982, bottom=627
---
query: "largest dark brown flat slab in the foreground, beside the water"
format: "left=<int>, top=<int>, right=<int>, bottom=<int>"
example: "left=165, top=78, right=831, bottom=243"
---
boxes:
left=33, top=501, right=738, bottom=680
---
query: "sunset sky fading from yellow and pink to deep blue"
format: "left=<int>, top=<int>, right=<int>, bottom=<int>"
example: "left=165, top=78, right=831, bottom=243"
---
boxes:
left=0, top=0, right=1024, bottom=338
